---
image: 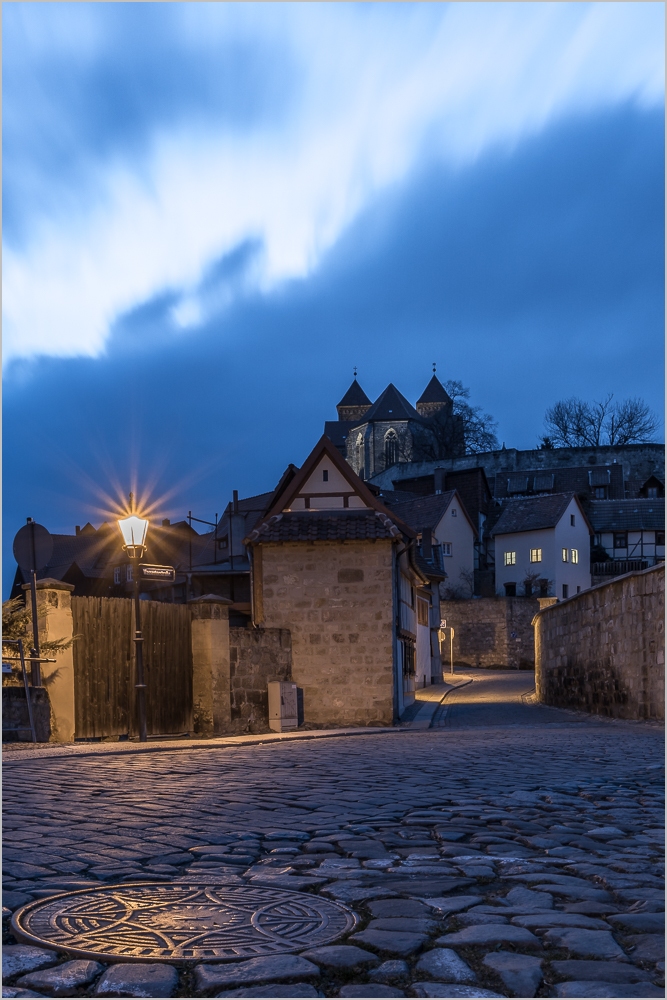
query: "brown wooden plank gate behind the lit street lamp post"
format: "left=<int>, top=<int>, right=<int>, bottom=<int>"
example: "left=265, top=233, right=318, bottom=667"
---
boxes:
left=72, top=597, right=192, bottom=739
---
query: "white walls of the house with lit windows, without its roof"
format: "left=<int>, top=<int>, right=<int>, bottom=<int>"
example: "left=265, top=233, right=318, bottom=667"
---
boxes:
left=496, top=498, right=591, bottom=599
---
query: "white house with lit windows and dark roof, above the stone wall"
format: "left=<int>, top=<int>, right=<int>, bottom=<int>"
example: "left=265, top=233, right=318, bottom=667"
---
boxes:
left=493, top=493, right=593, bottom=600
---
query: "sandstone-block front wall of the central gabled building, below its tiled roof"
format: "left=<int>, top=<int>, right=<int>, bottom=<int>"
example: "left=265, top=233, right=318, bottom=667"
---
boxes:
left=255, top=540, right=394, bottom=726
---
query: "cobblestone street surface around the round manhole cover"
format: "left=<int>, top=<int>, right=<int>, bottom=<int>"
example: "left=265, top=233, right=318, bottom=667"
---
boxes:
left=3, top=670, right=664, bottom=997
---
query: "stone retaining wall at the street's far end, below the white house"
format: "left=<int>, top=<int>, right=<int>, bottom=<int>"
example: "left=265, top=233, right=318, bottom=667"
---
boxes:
left=440, top=597, right=539, bottom=670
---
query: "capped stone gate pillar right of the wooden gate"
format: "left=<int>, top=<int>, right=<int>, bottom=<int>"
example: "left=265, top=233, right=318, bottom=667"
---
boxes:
left=188, top=594, right=233, bottom=736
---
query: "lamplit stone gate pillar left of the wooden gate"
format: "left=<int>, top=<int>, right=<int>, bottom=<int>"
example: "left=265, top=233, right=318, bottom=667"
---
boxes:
left=23, top=579, right=75, bottom=743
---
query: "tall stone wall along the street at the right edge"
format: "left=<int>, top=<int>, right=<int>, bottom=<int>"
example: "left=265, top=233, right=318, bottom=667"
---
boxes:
left=535, top=565, right=665, bottom=719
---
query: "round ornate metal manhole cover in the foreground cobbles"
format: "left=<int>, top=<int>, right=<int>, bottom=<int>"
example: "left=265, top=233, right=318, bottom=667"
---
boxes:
left=12, top=882, right=357, bottom=962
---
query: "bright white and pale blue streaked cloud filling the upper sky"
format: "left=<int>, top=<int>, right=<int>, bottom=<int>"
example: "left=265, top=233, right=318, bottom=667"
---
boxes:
left=3, top=3, right=663, bottom=359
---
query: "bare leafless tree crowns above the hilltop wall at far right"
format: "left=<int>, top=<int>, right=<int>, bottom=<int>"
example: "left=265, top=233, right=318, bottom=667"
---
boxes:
left=541, top=393, right=658, bottom=448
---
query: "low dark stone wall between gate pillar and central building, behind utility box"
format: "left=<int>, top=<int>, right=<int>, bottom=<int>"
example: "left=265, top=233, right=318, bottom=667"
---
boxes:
left=229, top=628, right=292, bottom=732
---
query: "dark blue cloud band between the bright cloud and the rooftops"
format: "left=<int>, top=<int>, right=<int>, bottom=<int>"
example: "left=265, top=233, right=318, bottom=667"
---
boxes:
left=4, top=105, right=663, bottom=588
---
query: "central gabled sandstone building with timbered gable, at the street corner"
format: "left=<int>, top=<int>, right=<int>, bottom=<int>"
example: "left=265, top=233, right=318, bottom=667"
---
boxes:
left=246, top=438, right=442, bottom=726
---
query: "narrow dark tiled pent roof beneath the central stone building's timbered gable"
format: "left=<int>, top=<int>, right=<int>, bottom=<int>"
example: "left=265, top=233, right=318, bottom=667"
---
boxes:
left=248, top=510, right=401, bottom=543
